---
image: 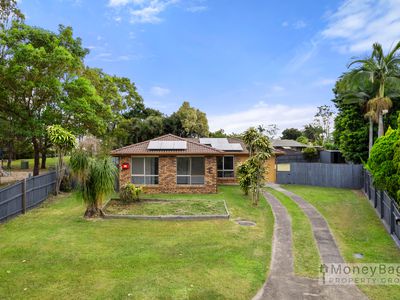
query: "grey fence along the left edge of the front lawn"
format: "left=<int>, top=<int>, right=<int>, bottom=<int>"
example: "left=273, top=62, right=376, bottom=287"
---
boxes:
left=0, top=171, right=57, bottom=222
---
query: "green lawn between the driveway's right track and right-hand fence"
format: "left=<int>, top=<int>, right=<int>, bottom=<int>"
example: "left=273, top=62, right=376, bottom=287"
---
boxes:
left=285, top=185, right=400, bottom=299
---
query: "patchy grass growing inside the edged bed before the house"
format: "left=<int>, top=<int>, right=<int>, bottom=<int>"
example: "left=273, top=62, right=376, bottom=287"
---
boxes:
left=105, top=196, right=227, bottom=216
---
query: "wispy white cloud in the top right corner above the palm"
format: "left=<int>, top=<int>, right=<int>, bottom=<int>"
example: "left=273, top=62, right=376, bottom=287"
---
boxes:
left=322, top=0, right=400, bottom=53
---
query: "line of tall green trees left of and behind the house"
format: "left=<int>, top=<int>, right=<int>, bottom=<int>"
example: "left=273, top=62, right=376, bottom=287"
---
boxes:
left=0, top=0, right=209, bottom=175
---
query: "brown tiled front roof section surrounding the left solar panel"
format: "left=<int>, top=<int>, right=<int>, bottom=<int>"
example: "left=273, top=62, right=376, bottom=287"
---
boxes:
left=111, top=134, right=224, bottom=156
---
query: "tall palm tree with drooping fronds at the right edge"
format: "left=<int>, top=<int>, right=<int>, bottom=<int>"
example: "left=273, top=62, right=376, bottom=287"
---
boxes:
left=348, top=42, right=400, bottom=137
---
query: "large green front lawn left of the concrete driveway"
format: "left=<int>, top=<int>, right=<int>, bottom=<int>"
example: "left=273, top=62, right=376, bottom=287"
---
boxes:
left=0, top=186, right=273, bottom=299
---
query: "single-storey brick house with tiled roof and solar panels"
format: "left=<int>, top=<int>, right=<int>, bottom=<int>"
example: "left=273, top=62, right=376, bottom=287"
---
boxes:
left=111, top=134, right=276, bottom=193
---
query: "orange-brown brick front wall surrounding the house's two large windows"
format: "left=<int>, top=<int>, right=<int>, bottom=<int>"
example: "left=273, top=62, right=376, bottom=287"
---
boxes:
left=119, top=156, right=217, bottom=194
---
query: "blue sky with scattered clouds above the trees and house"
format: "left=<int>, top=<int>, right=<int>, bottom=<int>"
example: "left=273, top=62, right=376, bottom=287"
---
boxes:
left=19, top=0, right=400, bottom=132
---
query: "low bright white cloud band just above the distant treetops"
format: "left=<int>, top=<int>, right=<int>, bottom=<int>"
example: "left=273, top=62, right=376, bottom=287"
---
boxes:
left=208, top=102, right=315, bottom=133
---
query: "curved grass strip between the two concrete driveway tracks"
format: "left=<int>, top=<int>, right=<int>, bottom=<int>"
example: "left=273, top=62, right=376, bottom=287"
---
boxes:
left=267, top=188, right=321, bottom=278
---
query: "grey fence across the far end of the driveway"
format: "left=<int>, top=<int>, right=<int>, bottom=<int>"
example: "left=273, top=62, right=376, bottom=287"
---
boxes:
left=276, top=162, right=364, bottom=189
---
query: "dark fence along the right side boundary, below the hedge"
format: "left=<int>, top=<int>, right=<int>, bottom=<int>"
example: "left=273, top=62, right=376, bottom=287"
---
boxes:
left=363, top=171, right=400, bottom=246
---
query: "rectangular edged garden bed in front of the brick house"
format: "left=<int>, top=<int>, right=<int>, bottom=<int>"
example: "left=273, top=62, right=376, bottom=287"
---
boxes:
left=103, top=199, right=229, bottom=220
